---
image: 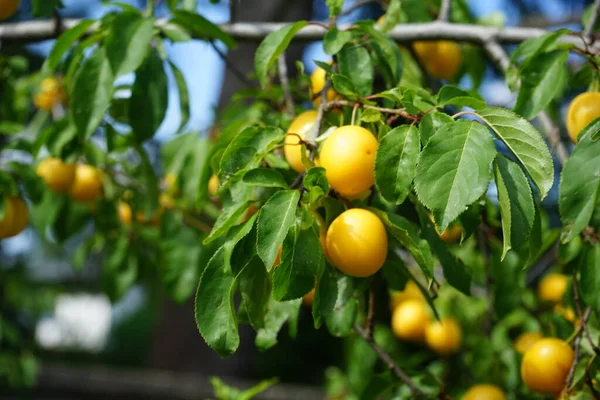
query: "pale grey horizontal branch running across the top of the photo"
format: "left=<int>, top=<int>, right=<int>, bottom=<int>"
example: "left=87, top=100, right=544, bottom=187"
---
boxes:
left=0, top=19, right=600, bottom=52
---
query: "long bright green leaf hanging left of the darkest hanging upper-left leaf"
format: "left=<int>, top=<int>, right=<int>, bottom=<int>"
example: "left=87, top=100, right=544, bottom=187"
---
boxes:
left=70, top=48, right=114, bottom=139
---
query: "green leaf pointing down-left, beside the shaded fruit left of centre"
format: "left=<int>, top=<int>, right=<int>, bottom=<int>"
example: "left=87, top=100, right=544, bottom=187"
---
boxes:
left=219, top=126, right=285, bottom=186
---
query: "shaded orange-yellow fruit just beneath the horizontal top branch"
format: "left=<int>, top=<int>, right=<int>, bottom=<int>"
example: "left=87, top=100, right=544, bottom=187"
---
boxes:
left=414, top=40, right=462, bottom=80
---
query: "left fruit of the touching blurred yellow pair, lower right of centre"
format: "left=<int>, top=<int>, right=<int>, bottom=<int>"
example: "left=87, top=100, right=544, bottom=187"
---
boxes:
left=392, top=300, right=431, bottom=342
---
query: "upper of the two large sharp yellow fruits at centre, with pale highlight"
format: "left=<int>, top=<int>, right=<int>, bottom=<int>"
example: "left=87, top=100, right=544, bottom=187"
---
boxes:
left=319, top=125, right=377, bottom=196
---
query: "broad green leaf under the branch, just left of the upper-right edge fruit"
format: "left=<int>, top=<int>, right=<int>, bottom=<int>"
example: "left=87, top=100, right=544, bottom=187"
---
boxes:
left=514, top=50, right=569, bottom=119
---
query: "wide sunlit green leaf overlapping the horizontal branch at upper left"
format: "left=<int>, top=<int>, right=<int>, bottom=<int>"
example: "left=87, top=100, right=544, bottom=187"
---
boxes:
left=105, top=12, right=154, bottom=77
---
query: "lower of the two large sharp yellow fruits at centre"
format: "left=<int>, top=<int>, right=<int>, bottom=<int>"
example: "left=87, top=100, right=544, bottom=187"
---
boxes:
left=326, top=208, right=387, bottom=277
